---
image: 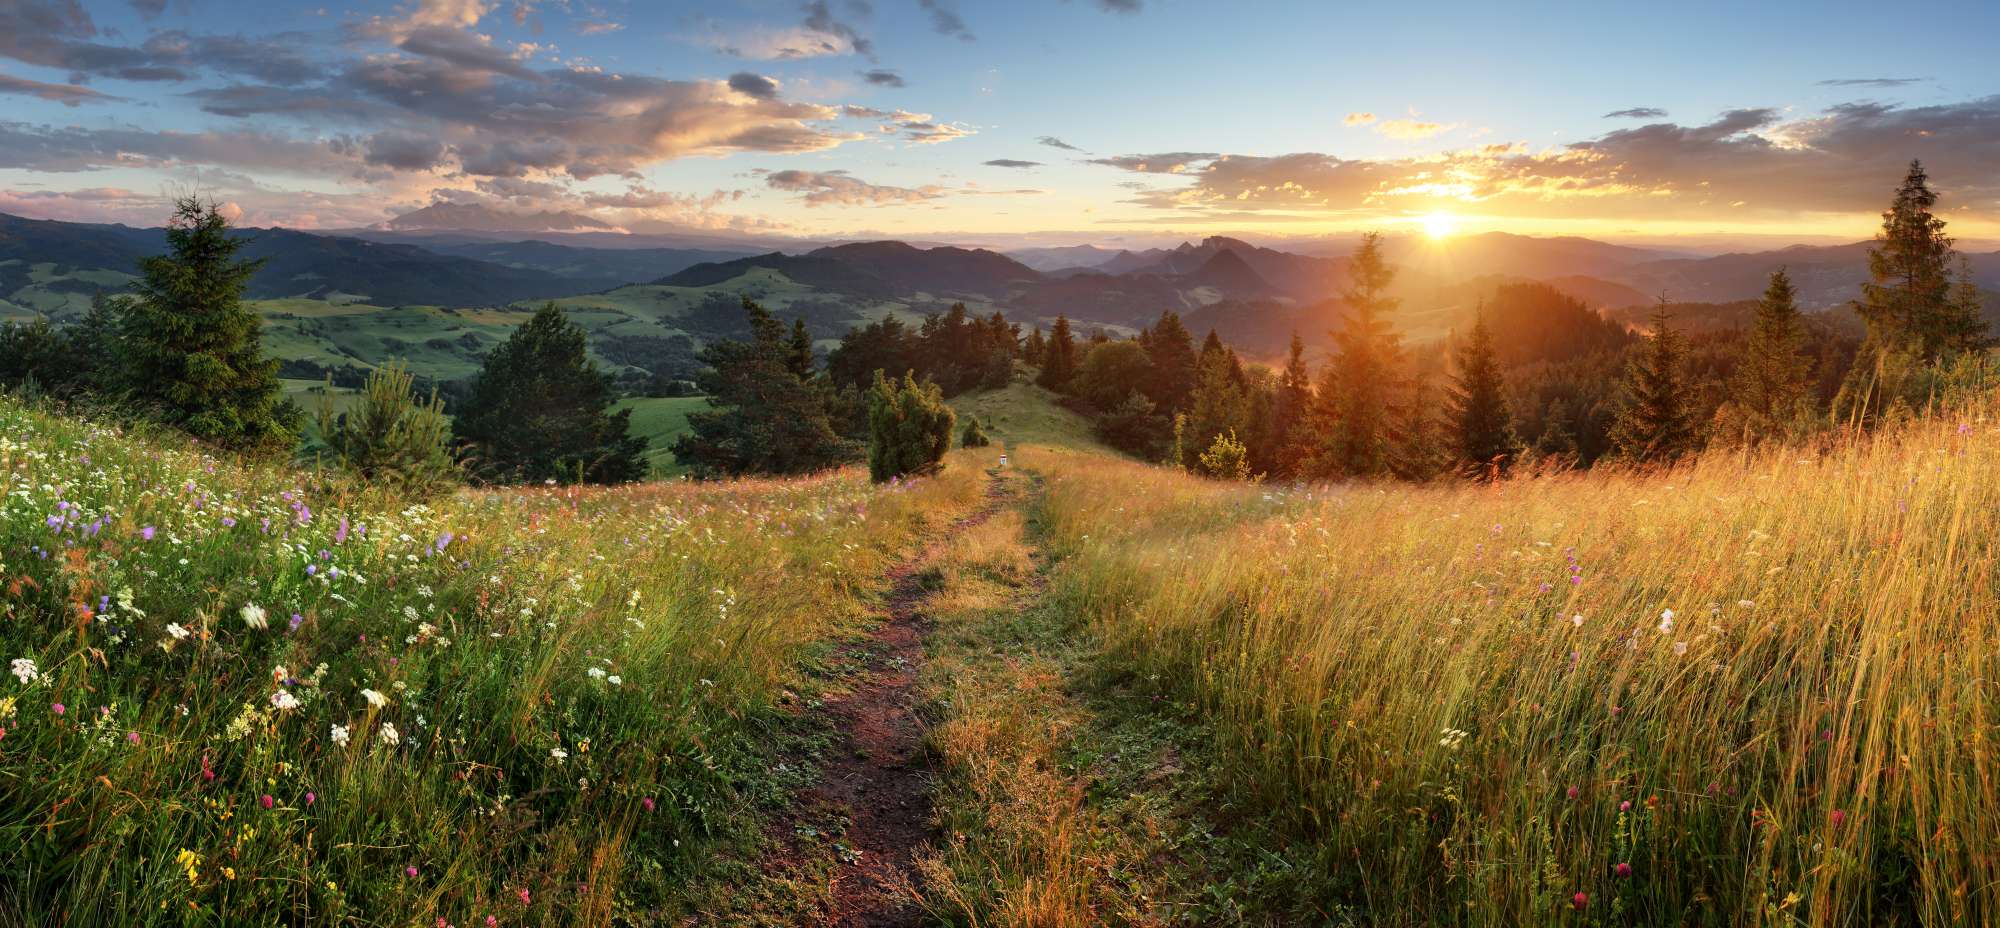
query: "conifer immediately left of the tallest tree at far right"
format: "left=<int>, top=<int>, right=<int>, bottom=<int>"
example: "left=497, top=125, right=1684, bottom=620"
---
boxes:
left=1730, top=268, right=1812, bottom=442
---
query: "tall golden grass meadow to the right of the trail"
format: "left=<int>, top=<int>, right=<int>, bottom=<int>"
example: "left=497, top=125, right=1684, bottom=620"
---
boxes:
left=1004, top=398, right=2000, bottom=926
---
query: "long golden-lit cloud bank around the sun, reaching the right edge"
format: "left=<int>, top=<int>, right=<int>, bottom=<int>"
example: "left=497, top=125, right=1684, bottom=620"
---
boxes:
left=1096, top=96, right=2000, bottom=220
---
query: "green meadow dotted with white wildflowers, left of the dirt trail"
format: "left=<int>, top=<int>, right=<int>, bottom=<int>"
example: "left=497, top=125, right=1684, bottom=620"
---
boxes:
left=0, top=400, right=982, bottom=926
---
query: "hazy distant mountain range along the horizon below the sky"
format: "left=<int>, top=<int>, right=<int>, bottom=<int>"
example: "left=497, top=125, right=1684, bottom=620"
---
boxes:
left=0, top=204, right=2000, bottom=380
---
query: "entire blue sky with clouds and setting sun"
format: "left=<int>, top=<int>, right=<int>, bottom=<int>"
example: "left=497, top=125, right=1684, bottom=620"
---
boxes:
left=0, top=0, right=2000, bottom=246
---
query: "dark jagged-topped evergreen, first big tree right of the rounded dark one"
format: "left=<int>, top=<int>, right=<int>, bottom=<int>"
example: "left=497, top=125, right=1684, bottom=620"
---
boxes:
left=674, top=298, right=856, bottom=476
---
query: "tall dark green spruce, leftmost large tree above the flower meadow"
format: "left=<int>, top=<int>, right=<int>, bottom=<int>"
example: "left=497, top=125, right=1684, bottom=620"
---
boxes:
left=120, top=196, right=300, bottom=452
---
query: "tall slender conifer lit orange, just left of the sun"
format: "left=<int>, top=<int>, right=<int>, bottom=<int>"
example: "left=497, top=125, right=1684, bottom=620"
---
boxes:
left=1332, top=232, right=1402, bottom=476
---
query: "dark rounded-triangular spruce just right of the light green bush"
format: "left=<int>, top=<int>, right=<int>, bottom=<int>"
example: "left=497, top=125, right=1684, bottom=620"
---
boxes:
left=454, top=302, right=646, bottom=484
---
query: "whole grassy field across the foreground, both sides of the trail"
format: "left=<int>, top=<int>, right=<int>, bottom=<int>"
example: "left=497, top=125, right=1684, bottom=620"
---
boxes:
left=0, top=384, right=2000, bottom=926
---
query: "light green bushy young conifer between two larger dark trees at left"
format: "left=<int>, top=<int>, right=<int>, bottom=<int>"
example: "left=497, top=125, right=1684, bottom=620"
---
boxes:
left=318, top=364, right=458, bottom=496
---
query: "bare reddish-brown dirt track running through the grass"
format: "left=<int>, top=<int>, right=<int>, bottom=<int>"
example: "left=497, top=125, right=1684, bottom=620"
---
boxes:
left=806, top=478, right=1006, bottom=928
